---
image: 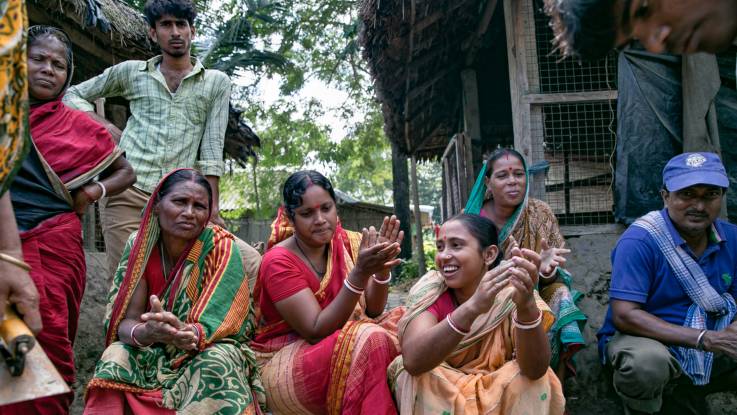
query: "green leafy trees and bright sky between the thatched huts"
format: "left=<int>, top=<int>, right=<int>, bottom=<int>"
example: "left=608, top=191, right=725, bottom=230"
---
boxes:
left=125, top=0, right=440, bottom=218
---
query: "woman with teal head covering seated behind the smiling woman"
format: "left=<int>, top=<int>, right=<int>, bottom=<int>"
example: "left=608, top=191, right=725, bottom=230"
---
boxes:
left=464, top=148, right=586, bottom=381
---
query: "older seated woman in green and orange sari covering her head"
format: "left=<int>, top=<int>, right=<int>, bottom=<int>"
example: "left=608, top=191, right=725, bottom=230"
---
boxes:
left=85, top=169, right=263, bottom=415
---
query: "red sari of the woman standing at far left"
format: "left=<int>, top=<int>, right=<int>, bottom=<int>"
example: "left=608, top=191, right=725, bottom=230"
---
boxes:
left=0, top=97, right=121, bottom=415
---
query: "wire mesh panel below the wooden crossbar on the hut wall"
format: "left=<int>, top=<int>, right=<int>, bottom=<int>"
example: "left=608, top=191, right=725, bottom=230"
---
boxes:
left=532, top=101, right=617, bottom=225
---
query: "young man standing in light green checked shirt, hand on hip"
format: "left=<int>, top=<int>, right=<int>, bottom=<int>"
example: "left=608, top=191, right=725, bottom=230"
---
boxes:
left=64, top=0, right=230, bottom=275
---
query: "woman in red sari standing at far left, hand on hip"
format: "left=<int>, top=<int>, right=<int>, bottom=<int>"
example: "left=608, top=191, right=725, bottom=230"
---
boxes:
left=0, top=26, right=135, bottom=414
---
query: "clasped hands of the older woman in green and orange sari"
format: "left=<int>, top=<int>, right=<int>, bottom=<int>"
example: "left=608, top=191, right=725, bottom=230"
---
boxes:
left=141, top=295, right=198, bottom=350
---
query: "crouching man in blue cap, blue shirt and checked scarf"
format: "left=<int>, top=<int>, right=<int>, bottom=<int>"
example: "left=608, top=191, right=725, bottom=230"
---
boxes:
left=598, top=153, right=737, bottom=414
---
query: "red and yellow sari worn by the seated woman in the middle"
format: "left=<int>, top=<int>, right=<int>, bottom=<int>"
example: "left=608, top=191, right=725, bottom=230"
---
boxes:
left=251, top=209, right=401, bottom=414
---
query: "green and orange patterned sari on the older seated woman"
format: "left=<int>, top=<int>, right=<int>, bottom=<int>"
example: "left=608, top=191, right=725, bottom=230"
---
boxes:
left=85, top=170, right=264, bottom=415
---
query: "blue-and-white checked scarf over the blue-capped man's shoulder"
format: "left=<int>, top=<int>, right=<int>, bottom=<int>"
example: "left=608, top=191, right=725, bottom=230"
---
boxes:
left=633, top=211, right=737, bottom=385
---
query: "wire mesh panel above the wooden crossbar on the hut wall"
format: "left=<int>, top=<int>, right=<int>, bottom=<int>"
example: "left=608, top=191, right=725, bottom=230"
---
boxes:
left=525, top=0, right=617, bottom=93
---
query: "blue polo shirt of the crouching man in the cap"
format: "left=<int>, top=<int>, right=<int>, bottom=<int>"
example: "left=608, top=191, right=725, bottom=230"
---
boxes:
left=597, top=209, right=737, bottom=361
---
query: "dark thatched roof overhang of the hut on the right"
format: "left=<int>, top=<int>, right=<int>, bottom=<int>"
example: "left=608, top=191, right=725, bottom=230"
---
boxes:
left=359, top=0, right=497, bottom=159
